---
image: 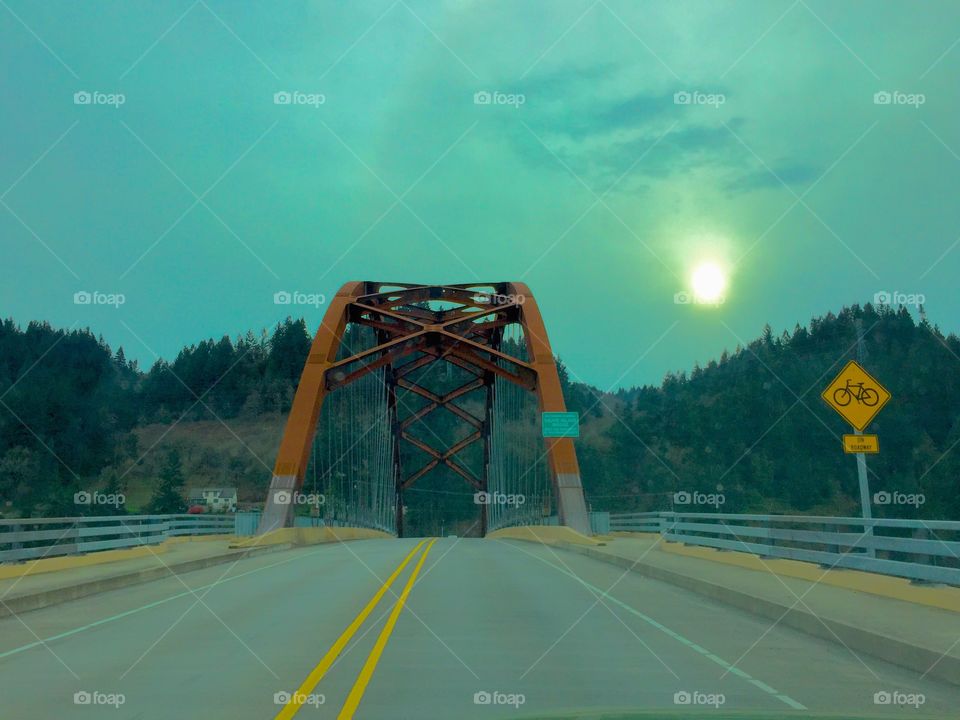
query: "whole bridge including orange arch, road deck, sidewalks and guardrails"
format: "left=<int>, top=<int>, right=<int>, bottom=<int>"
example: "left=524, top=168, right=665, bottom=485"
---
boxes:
left=0, top=282, right=960, bottom=720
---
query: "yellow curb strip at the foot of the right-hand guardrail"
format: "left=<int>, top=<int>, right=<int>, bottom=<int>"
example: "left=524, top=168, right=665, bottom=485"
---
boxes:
left=659, top=542, right=960, bottom=612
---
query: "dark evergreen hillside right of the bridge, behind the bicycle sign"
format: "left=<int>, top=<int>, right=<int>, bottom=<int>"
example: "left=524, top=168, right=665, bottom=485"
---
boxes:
left=574, top=305, right=960, bottom=518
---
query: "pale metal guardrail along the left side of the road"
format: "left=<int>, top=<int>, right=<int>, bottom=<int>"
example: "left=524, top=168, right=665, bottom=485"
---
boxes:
left=0, top=514, right=234, bottom=562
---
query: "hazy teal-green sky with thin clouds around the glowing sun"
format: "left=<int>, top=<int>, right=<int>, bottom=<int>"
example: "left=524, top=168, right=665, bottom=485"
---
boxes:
left=0, top=0, right=960, bottom=390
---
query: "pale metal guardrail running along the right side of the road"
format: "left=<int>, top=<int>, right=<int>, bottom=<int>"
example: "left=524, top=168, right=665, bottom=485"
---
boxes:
left=610, top=512, right=960, bottom=586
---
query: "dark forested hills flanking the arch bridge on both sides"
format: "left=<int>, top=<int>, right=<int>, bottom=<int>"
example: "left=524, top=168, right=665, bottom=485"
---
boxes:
left=0, top=305, right=960, bottom=522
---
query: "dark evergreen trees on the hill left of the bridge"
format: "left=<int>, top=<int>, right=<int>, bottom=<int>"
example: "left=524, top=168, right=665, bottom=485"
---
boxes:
left=0, top=319, right=310, bottom=516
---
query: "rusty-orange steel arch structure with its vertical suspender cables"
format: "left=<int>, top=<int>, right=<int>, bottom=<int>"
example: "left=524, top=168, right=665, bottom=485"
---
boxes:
left=258, top=281, right=590, bottom=535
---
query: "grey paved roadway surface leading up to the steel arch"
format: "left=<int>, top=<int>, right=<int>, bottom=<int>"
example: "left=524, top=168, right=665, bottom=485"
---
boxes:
left=0, top=538, right=960, bottom=720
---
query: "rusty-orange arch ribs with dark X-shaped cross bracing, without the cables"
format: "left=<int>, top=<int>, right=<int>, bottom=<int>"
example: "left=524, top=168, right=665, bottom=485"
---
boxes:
left=258, top=281, right=590, bottom=534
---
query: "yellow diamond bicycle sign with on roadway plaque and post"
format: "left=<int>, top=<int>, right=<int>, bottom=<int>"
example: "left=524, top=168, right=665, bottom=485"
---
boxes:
left=820, top=360, right=891, bottom=557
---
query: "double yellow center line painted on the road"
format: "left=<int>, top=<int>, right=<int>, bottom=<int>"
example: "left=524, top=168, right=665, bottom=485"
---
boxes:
left=275, top=539, right=436, bottom=720
